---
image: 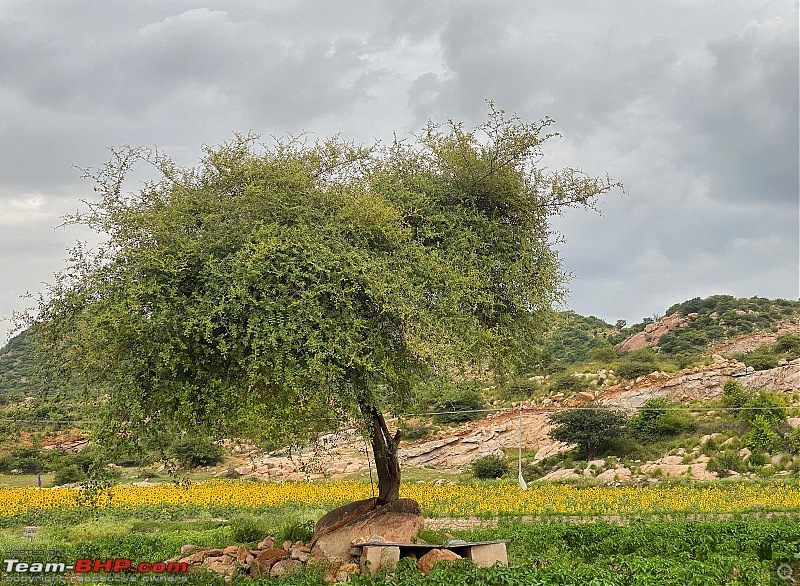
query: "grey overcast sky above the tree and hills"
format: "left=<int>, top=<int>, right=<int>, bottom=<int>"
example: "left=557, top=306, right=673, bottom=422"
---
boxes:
left=0, top=0, right=800, bottom=343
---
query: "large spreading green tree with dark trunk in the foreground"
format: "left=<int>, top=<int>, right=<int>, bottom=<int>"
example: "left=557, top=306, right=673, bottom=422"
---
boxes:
left=33, top=105, right=615, bottom=502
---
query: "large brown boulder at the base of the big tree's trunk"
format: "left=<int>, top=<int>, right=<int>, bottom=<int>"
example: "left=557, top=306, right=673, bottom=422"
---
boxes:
left=311, top=498, right=423, bottom=564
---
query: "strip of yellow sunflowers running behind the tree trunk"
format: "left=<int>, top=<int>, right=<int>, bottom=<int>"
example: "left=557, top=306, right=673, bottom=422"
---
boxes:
left=0, top=480, right=800, bottom=517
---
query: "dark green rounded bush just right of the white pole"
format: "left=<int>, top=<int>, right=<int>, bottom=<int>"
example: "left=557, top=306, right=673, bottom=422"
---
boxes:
left=549, top=403, right=627, bottom=459
